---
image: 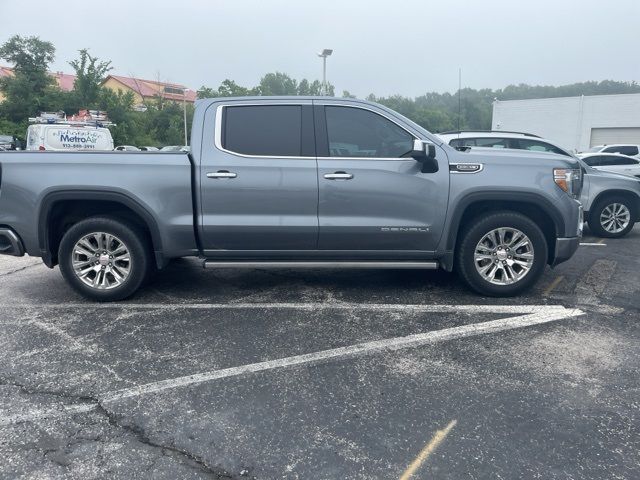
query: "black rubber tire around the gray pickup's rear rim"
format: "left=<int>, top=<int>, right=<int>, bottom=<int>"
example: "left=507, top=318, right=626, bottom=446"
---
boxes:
left=58, top=217, right=155, bottom=302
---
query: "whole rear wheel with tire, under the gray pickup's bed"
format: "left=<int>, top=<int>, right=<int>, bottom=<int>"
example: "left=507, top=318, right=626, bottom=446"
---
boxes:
left=58, top=217, right=153, bottom=302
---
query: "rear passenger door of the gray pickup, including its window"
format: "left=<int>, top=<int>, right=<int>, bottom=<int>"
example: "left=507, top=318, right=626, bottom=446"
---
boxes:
left=200, top=101, right=318, bottom=251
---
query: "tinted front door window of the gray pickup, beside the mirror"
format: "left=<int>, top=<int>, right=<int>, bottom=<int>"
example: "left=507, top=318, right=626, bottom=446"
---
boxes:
left=325, top=106, right=414, bottom=158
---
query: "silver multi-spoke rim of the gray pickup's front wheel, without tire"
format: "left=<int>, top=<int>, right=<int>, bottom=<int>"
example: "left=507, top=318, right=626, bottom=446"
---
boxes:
left=473, top=227, right=534, bottom=285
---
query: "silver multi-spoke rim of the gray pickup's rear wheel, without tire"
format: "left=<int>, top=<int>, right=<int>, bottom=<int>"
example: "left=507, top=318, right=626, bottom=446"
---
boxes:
left=72, top=232, right=131, bottom=290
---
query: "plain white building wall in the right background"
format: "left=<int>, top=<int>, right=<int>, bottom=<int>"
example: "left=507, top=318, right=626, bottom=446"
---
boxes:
left=492, top=94, right=640, bottom=151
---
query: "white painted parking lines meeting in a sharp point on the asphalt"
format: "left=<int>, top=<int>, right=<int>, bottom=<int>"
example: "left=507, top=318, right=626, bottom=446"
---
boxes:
left=0, top=303, right=584, bottom=426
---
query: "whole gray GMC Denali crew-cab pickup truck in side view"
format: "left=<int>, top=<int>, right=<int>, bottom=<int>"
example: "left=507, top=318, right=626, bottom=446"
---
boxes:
left=0, top=97, right=583, bottom=301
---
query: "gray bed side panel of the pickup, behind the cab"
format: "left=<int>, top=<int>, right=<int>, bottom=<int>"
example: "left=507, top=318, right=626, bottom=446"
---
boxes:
left=0, top=151, right=198, bottom=266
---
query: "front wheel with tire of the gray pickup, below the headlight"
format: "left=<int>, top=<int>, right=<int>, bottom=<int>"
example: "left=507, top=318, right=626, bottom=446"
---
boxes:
left=456, top=212, right=548, bottom=297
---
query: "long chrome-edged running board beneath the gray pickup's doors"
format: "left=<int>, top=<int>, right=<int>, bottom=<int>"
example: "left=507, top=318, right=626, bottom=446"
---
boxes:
left=202, top=260, right=439, bottom=270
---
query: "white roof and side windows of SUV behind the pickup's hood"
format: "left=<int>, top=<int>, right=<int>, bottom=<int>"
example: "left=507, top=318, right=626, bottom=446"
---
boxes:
left=438, top=130, right=573, bottom=157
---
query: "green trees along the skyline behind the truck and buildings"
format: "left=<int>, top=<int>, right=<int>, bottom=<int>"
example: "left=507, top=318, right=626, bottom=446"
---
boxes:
left=0, top=35, right=640, bottom=146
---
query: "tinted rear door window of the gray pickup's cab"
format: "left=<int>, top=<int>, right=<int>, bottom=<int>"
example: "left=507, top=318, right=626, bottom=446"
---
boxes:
left=221, top=105, right=302, bottom=157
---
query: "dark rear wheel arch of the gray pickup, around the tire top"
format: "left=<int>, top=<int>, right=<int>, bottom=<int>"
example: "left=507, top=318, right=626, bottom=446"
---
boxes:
left=38, top=189, right=165, bottom=268
